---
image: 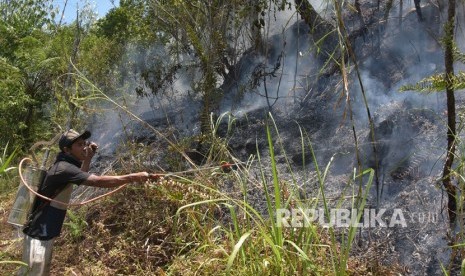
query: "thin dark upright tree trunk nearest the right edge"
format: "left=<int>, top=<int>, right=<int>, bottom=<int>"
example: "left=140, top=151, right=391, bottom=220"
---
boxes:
left=442, top=0, right=457, bottom=224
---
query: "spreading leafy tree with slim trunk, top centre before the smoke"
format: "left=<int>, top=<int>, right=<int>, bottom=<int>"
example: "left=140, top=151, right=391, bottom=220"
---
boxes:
left=145, top=0, right=288, bottom=134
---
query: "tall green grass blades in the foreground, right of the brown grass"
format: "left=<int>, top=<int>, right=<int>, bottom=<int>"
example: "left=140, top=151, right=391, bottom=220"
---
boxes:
left=170, top=115, right=374, bottom=275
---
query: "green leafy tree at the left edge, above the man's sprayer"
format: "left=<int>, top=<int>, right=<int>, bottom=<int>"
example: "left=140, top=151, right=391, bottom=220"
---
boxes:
left=0, top=0, right=60, bottom=148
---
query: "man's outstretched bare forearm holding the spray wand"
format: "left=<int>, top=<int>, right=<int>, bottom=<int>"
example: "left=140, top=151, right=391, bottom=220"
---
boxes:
left=82, top=172, right=154, bottom=188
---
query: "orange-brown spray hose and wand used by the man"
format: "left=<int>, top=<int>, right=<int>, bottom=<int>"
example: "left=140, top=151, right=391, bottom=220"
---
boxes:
left=18, top=157, right=235, bottom=207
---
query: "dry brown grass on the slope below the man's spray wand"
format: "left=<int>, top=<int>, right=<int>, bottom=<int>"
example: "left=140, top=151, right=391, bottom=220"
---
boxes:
left=0, top=174, right=398, bottom=275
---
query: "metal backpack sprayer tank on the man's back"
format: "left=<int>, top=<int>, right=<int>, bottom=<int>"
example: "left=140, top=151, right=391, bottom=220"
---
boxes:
left=7, top=134, right=61, bottom=227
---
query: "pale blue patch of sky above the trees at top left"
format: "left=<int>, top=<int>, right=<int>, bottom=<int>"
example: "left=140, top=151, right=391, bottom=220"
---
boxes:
left=53, top=0, right=119, bottom=24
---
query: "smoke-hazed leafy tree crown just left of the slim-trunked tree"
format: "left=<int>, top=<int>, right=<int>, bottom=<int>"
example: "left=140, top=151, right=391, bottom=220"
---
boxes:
left=89, top=0, right=163, bottom=95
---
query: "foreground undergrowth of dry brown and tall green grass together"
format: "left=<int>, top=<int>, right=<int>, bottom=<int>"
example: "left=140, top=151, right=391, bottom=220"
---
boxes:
left=0, top=111, right=395, bottom=275
